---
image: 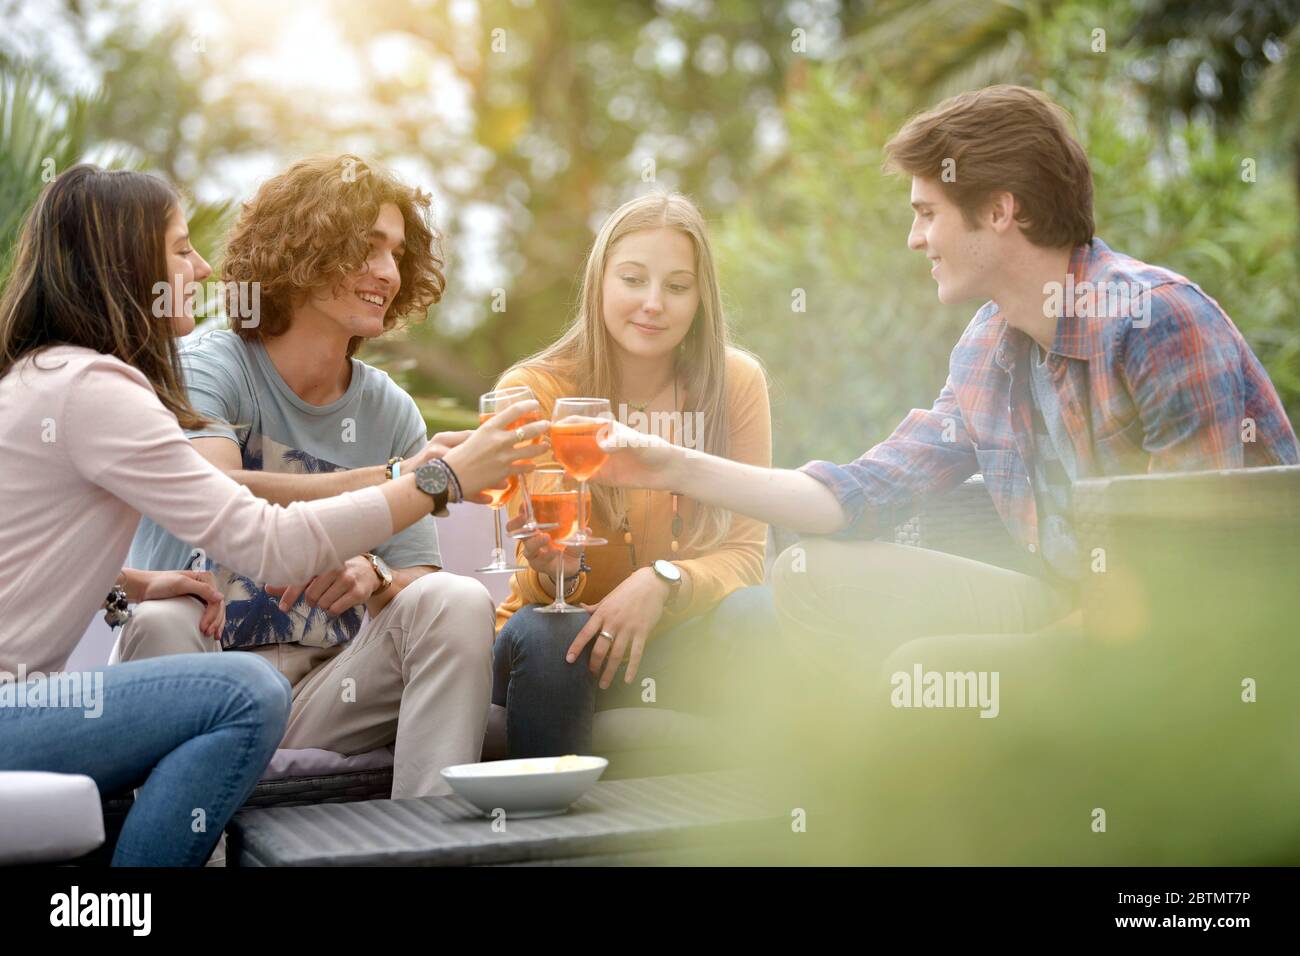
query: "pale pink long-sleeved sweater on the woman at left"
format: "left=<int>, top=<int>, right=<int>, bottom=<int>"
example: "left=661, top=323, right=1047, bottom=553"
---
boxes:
left=0, top=346, right=394, bottom=674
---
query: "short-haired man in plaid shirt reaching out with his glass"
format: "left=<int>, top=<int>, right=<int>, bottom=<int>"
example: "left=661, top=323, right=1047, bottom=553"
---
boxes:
left=598, top=86, right=1297, bottom=670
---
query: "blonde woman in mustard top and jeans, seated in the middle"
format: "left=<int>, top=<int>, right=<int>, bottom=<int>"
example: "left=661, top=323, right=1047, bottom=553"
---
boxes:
left=493, top=194, right=772, bottom=757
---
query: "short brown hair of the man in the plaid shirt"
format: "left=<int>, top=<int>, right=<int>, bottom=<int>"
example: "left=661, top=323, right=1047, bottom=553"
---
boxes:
left=885, top=86, right=1095, bottom=247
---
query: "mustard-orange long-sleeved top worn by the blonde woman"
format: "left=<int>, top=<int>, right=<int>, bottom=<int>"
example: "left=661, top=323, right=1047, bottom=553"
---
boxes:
left=497, top=349, right=772, bottom=631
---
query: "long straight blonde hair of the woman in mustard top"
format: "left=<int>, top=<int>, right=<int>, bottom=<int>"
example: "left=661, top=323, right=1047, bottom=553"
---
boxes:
left=507, top=193, right=754, bottom=550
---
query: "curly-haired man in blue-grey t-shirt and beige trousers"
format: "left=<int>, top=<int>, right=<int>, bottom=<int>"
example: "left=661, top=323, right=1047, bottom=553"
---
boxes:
left=114, top=156, right=493, bottom=797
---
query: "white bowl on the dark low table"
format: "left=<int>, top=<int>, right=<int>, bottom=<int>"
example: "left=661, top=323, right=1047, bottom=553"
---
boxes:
left=442, top=754, right=610, bottom=819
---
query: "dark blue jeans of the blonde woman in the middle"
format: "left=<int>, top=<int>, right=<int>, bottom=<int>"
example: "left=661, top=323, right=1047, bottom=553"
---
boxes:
left=493, top=587, right=780, bottom=757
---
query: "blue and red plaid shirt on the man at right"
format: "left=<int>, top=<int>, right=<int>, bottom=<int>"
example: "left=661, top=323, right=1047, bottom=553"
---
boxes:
left=801, top=239, right=1300, bottom=551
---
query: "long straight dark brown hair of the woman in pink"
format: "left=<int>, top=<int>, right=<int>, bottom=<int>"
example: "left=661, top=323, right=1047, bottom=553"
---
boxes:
left=0, top=164, right=207, bottom=429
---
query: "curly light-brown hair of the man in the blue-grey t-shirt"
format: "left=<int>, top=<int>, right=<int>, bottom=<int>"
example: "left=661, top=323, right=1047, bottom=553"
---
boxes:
left=221, top=153, right=446, bottom=358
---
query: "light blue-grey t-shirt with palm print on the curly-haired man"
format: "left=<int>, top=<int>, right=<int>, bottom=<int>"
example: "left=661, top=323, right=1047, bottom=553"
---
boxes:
left=126, top=330, right=442, bottom=648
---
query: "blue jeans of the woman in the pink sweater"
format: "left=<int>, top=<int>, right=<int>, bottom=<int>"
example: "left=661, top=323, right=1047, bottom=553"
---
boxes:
left=0, top=654, right=290, bottom=866
